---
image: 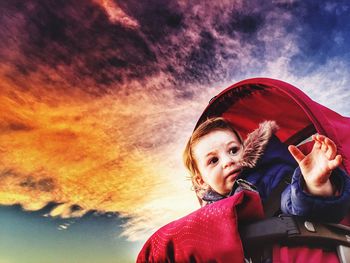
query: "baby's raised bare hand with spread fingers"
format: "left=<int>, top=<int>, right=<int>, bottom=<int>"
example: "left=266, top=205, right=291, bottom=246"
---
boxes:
left=288, top=135, right=342, bottom=196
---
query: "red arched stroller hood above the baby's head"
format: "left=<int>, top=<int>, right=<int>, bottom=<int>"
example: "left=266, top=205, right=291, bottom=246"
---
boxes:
left=196, top=78, right=350, bottom=173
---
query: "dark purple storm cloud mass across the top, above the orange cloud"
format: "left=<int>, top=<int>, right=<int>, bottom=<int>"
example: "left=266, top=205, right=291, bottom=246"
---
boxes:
left=0, top=0, right=300, bottom=93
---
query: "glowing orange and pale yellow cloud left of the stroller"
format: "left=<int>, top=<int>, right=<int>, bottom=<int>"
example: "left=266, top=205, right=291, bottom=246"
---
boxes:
left=0, top=69, right=211, bottom=240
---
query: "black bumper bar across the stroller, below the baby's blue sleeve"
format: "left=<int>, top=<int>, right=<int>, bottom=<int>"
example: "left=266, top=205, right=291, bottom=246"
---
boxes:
left=239, top=215, right=350, bottom=262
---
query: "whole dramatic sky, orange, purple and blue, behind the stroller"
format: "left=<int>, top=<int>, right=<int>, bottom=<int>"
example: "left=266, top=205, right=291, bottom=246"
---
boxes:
left=0, top=0, right=350, bottom=263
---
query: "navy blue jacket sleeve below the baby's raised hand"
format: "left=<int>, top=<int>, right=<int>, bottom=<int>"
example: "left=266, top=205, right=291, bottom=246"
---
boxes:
left=281, top=167, right=350, bottom=222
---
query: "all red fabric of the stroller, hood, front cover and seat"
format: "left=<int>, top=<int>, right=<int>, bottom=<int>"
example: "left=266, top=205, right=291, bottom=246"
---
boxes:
left=137, top=78, right=350, bottom=262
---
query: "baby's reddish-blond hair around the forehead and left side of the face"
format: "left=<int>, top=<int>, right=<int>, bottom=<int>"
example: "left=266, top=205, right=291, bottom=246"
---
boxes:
left=183, top=117, right=243, bottom=198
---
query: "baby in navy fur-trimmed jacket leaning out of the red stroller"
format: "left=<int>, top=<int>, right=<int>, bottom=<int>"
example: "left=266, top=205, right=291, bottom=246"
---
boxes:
left=184, top=117, right=350, bottom=222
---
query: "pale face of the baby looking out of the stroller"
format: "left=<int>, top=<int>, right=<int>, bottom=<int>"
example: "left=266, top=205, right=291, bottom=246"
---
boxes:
left=193, top=130, right=243, bottom=195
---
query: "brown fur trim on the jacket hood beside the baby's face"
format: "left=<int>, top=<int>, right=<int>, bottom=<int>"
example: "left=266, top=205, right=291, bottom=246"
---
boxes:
left=240, top=121, right=278, bottom=168
